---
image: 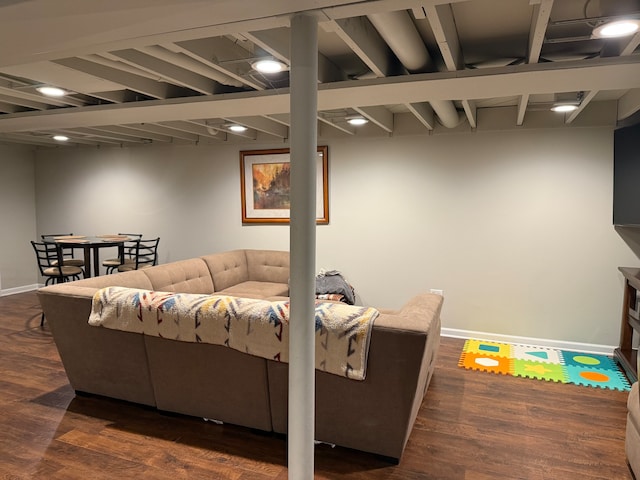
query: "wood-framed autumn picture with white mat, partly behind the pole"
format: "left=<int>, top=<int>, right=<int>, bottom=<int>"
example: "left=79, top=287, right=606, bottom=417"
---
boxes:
left=240, top=146, right=329, bottom=224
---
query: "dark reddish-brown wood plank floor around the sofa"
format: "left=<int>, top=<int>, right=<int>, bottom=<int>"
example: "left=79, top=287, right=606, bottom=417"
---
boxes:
left=0, top=292, right=632, bottom=480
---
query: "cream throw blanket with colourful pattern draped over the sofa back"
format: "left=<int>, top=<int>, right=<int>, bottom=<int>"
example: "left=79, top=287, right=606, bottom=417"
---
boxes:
left=89, top=287, right=379, bottom=380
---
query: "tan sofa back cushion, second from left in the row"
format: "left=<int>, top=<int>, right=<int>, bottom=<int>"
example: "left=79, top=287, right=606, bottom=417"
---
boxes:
left=142, top=258, right=213, bottom=293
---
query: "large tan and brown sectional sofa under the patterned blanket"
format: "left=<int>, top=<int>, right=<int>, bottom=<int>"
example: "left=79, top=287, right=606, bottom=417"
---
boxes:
left=38, top=250, right=442, bottom=459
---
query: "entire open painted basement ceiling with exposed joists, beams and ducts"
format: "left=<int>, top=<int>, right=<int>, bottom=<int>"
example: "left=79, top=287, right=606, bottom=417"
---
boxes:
left=0, top=0, right=640, bottom=147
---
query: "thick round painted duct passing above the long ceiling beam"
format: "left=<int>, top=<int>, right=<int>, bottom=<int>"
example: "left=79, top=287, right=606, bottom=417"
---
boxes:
left=367, top=10, right=464, bottom=128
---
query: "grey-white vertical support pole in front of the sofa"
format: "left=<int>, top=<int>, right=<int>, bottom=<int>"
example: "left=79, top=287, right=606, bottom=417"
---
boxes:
left=288, top=14, right=318, bottom=480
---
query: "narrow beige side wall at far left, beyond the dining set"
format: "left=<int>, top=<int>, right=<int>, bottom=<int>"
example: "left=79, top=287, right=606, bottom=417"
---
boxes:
left=0, top=145, right=38, bottom=294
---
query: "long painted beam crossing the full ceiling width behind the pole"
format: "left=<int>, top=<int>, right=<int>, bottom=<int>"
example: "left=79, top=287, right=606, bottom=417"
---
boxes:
left=0, top=56, right=640, bottom=131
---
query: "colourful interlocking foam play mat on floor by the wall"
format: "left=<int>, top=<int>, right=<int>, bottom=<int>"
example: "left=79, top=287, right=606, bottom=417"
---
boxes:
left=458, top=339, right=631, bottom=391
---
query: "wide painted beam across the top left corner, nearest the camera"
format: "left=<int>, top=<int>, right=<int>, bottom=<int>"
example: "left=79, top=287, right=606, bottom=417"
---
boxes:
left=0, top=0, right=362, bottom=66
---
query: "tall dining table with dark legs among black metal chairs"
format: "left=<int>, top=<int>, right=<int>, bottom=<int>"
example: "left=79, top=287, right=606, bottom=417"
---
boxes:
left=43, top=234, right=131, bottom=278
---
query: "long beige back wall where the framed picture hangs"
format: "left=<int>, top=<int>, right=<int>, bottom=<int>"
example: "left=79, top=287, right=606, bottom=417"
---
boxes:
left=36, top=128, right=640, bottom=345
